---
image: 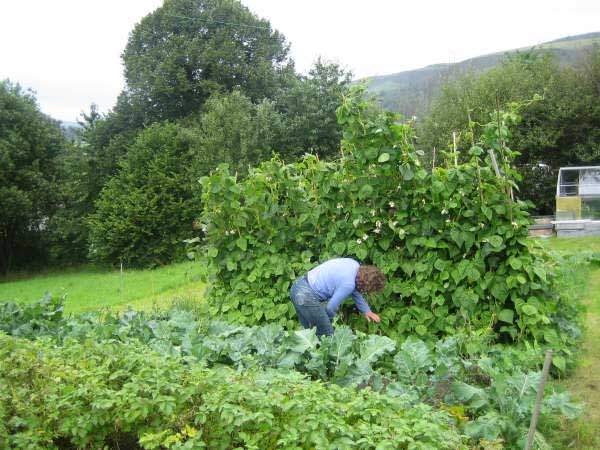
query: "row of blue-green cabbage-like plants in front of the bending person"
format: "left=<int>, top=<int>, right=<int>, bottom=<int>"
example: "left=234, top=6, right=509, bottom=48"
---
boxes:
left=0, top=298, right=579, bottom=448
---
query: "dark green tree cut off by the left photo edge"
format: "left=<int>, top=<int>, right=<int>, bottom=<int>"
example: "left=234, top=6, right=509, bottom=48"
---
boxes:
left=0, top=80, right=65, bottom=273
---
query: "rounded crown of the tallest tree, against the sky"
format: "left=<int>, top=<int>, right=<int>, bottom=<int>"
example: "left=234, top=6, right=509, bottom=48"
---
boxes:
left=122, top=0, right=293, bottom=121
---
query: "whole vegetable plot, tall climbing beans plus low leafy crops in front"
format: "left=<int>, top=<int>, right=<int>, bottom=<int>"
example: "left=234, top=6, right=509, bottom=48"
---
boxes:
left=0, top=87, right=597, bottom=450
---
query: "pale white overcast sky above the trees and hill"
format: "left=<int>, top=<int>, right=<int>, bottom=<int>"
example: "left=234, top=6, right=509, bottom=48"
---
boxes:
left=0, top=0, right=600, bottom=121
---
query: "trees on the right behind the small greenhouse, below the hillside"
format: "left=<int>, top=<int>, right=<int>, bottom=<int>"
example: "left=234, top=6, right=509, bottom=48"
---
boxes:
left=419, top=45, right=600, bottom=214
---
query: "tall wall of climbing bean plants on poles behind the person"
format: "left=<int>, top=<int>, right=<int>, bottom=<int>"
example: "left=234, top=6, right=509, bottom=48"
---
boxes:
left=201, top=88, right=573, bottom=348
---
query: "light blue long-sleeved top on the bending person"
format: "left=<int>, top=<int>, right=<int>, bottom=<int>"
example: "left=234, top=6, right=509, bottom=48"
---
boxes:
left=307, top=258, right=371, bottom=320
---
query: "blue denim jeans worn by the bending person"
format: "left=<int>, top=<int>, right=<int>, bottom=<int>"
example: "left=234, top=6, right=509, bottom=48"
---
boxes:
left=290, top=276, right=333, bottom=337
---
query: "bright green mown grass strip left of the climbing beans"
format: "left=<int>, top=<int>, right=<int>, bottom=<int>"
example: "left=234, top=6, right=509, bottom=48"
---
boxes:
left=0, top=261, right=203, bottom=313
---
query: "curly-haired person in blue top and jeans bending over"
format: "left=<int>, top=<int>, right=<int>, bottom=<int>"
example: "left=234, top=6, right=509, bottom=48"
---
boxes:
left=290, top=258, right=385, bottom=337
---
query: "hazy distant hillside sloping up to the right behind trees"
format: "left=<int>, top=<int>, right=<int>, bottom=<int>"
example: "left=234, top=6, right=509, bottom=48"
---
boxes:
left=369, top=32, right=600, bottom=117
